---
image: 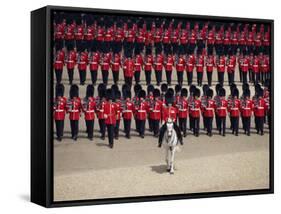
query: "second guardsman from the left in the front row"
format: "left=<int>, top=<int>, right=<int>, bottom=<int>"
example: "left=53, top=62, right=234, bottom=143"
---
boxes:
left=67, top=85, right=82, bottom=141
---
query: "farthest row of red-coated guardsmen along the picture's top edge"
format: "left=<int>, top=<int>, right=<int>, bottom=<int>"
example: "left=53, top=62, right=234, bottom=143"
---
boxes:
left=53, top=14, right=270, bottom=57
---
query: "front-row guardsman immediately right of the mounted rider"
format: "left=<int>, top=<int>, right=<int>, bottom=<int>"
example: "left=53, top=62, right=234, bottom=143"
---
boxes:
left=178, top=88, right=188, bottom=137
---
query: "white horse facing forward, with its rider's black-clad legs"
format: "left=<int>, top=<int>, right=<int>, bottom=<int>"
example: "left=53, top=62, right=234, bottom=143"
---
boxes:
left=158, top=118, right=182, bottom=174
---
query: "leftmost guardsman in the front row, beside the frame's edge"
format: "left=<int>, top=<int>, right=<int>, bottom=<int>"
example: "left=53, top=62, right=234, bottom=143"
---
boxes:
left=54, top=83, right=66, bottom=141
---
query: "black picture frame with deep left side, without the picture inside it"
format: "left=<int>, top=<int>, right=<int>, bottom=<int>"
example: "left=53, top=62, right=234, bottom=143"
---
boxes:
left=31, top=6, right=274, bottom=207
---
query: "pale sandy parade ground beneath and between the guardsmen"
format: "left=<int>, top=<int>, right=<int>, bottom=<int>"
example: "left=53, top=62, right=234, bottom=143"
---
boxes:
left=54, top=66, right=270, bottom=201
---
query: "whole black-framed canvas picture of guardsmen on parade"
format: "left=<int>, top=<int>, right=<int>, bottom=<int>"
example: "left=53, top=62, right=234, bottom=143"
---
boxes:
left=31, top=6, right=274, bottom=207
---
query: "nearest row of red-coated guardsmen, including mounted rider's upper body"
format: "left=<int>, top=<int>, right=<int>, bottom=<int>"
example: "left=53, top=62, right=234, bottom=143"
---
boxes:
left=54, top=83, right=271, bottom=148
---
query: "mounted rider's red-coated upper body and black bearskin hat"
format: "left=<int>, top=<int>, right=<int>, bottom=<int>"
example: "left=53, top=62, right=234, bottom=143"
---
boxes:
left=162, top=88, right=178, bottom=122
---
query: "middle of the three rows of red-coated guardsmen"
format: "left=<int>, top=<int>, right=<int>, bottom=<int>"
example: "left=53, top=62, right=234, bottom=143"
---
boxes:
left=54, top=50, right=270, bottom=86
